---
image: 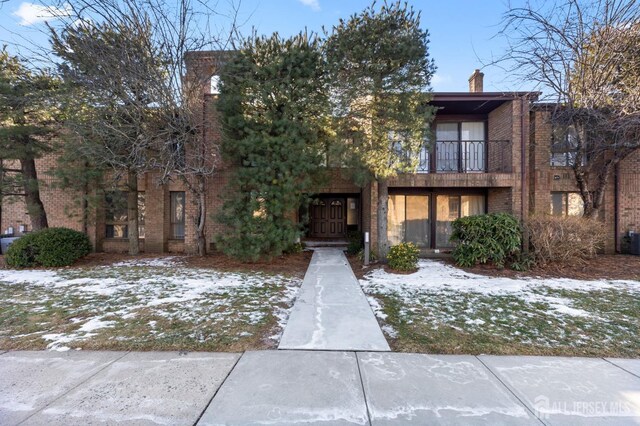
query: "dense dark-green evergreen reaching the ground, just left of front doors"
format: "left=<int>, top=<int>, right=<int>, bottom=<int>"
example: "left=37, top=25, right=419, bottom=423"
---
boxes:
left=218, top=34, right=328, bottom=260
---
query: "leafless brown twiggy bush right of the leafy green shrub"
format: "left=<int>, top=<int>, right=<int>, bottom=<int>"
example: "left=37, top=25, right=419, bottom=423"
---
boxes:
left=526, top=216, right=606, bottom=266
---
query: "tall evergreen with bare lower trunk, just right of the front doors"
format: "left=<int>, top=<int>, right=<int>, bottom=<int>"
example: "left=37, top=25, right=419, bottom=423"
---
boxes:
left=326, top=1, right=435, bottom=257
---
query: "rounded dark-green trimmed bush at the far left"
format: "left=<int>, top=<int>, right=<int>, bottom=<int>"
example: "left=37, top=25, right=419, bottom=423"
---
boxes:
left=5, top=228, right=91, bottom=268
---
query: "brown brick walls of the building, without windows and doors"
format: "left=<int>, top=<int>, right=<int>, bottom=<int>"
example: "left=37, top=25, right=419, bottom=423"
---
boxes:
left=1, top=52, right=640, bottom=253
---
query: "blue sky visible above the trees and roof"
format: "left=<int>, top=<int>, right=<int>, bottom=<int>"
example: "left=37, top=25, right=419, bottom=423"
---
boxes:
left=0, top=0, right=526, bottom=92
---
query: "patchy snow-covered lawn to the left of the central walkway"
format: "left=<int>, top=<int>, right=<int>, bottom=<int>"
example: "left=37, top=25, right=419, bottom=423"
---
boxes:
left=0, top=258, right=301, bottom=351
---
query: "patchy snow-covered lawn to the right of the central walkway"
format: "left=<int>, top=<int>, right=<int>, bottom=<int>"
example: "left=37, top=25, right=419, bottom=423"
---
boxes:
left=360, top=260, right=640, bottom=357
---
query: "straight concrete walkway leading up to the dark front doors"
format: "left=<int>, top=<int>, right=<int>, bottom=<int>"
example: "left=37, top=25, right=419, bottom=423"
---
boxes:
left=278, top=248, right=390, bottom=351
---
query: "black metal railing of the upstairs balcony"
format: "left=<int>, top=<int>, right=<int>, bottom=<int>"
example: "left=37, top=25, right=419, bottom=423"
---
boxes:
left=416, top=140, right=512, bottom=173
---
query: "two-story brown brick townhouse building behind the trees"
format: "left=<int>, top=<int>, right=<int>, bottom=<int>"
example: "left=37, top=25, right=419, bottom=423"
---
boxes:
left=1, top=52, right=640, bottom=253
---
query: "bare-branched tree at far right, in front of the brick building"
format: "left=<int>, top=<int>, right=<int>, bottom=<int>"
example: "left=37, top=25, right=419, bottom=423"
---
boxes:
left=497, top=0, right=640, bottom=216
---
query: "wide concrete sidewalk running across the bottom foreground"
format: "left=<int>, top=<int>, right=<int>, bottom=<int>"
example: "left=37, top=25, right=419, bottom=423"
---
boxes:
left=0, top=350, right=640, bottom=425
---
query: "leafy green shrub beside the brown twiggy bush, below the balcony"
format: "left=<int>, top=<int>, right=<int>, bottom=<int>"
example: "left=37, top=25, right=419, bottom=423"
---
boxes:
left=451, top=213, right=522, bottom=267
